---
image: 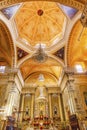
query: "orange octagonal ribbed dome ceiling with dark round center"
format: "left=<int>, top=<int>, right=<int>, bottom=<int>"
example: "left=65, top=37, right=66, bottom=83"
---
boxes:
left=14, top=1, right=67, bottom=47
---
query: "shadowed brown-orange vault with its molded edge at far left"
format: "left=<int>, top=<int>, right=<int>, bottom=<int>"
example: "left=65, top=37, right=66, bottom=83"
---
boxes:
left=0, top=20, right=15, bottom=67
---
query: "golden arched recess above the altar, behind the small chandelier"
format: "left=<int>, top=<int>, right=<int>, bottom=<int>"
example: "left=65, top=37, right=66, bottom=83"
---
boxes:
left=25, top=71, right=58, bottom=87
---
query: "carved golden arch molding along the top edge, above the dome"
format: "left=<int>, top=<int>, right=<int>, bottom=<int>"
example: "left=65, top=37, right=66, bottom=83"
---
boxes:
left=0, top=0, right=85, bottom=10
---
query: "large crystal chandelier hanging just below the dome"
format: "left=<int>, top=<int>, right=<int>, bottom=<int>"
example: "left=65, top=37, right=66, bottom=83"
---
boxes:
left=33, top=44, right=48, bottom=63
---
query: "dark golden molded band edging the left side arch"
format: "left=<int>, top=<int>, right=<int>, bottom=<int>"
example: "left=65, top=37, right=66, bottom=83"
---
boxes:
left=0, top=20, right=15, bottom=67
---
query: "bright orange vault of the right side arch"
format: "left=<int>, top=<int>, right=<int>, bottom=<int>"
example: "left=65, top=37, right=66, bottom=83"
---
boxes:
left=67, top=20, right=87, bottom=69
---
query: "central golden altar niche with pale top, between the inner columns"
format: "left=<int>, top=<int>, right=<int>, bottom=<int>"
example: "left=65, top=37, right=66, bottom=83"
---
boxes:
left=34, top=87, right=49, bottom=117
